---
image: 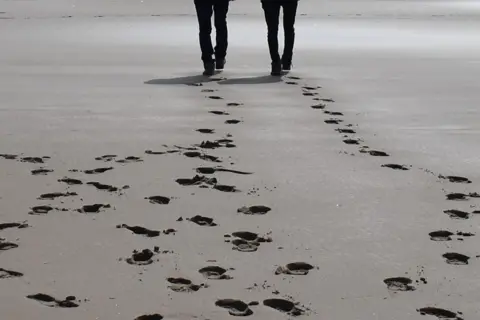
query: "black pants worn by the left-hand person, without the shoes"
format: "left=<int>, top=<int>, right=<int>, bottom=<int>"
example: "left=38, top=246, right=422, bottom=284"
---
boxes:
left=195, top=0, right=229, bottom=62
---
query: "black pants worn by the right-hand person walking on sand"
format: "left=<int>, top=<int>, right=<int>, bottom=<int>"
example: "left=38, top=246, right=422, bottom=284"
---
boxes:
left=262, top=0, right=298, bottom=63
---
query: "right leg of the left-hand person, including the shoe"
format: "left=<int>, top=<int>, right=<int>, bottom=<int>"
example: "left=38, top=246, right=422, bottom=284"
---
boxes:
left=213, top=0, right=229, bottom=69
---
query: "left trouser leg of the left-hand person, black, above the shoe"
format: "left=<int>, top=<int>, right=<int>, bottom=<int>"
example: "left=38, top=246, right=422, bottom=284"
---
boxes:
left=195, top=0, right=213, bottom=62
